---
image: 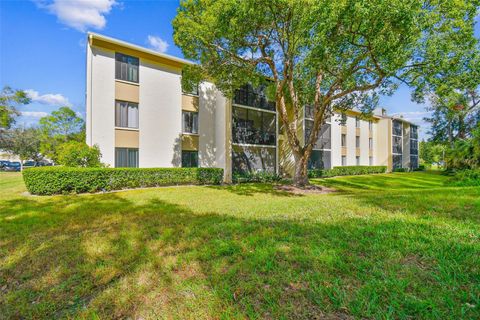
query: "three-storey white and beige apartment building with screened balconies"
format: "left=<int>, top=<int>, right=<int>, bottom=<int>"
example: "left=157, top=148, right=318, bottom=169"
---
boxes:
left=86, top=33, right=418, bottom=182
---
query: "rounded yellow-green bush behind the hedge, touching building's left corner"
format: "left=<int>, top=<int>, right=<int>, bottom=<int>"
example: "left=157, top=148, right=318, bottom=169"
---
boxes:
left=57, top=141, right=103, bottom=167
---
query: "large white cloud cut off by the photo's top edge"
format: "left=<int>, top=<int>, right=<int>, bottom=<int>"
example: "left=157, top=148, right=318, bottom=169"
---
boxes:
left=33, top=0, right=116, bottom=32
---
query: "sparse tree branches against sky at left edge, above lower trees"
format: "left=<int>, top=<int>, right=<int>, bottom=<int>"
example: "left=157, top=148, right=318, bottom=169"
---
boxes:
left=0, top=86, right=31, bottom=132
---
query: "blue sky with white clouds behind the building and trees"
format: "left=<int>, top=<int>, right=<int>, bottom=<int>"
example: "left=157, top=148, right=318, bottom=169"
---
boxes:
left=0, top=0, right=480, bottom=140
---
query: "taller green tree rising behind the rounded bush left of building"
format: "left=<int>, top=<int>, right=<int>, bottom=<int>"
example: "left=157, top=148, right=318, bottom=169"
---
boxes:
left=39, top=107, right=85, bottom=161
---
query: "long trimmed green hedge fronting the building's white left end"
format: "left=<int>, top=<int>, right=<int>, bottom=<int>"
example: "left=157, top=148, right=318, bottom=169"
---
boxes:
left=23, top=167, right=223, bottom=195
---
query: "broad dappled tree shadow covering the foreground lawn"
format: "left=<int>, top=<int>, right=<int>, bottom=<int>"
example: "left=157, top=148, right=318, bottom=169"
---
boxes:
left=0, top=194, right=479, bottom=319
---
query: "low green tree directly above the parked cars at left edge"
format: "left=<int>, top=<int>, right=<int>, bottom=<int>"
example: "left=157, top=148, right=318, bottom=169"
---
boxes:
left=0, top=128, right=43, bottom=170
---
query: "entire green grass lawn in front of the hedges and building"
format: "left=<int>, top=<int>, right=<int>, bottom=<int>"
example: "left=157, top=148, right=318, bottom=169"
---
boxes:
left=0, top=173, right=480, bottom=319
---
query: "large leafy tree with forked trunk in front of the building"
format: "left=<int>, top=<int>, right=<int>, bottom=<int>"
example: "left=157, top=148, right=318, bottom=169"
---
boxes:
left=173, top=0, right=478, bottom=186
